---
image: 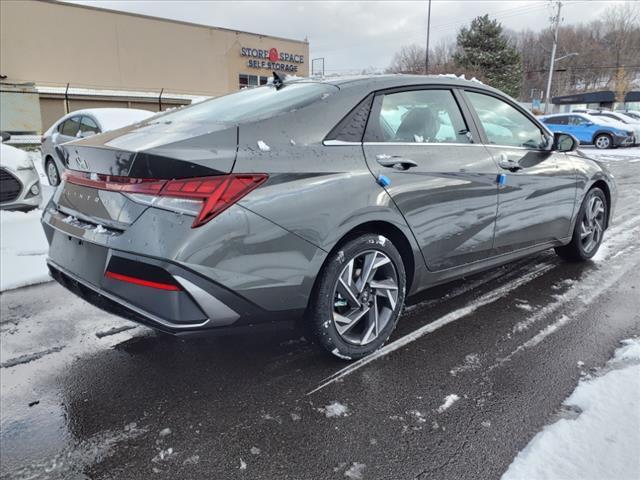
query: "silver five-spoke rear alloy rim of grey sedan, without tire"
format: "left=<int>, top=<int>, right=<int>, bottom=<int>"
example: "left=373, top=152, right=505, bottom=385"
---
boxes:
left=333, top=250, right=398, bottom=345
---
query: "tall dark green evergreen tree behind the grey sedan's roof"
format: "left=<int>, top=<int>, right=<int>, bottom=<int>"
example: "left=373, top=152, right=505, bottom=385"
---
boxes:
left=453, top=15, right=522, bottom=97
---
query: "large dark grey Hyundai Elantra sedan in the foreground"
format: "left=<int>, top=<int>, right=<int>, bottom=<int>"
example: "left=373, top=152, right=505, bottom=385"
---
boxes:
left=42, top=75, right=616, bottom=359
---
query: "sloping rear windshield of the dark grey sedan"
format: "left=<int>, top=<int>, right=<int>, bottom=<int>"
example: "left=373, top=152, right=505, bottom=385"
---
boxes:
left=153, top=83, right=338, bottom=123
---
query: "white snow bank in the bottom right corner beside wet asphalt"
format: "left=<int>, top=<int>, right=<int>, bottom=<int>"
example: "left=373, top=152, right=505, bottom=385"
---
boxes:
left=502, top=338, right=640, bottom=480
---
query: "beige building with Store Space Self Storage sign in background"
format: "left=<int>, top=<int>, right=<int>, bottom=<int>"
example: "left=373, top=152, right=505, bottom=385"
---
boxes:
left=0, top=0, right=310, bottom=130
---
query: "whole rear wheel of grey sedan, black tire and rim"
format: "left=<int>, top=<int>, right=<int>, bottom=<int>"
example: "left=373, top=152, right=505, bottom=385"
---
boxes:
left=306, top=234, right=406, bottom=360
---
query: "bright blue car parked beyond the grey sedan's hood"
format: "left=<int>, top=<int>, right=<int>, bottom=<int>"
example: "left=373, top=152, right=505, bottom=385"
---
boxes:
left=540, top=113, right=635, bottom=148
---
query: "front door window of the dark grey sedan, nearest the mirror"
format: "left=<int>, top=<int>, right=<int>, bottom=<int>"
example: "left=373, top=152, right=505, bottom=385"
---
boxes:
left=466, top=92, right=547, bottom=149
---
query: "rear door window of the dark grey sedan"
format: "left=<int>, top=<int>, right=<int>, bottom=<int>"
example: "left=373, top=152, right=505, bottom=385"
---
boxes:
left=365, top=90, right=471, bottom=143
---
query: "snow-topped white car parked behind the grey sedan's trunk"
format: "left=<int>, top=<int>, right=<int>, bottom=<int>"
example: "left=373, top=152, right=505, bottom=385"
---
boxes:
left=41, top=108, right=155, bottom=187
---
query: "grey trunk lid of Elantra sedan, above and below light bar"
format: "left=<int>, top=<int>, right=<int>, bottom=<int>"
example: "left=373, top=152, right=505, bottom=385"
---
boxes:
left=53, top=117, right=238, bottom=231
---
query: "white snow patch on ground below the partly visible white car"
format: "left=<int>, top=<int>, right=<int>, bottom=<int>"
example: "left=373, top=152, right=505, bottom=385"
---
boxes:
left=0, top=210, right=50, bottom=291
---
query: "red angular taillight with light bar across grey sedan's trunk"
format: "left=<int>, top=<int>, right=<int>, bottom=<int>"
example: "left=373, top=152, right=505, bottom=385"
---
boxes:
left=65, top=170, right=268, bottom=228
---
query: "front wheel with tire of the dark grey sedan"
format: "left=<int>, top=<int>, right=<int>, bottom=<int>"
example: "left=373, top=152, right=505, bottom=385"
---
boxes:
left=555, top=187, right=609, bottom=262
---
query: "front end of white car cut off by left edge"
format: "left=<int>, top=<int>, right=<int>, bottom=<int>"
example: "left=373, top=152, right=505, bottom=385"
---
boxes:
left=0, top=132, right=42, bottom=211
